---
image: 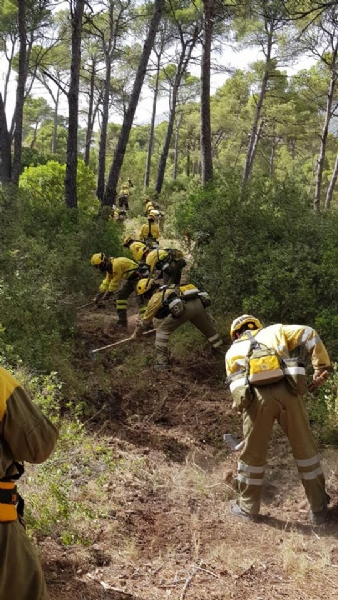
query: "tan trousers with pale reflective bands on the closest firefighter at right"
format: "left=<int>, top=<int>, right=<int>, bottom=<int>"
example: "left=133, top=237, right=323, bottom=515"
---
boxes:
left=238, top=381, right=326, bottom=514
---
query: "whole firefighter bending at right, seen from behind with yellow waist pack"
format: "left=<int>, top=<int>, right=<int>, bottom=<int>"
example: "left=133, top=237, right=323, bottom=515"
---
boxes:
left=225, top=315, right=330, bottom=525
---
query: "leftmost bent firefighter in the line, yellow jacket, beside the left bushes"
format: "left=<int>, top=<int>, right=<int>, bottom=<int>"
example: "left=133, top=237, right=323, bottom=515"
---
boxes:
left=90, top=252, right=148, bottom=328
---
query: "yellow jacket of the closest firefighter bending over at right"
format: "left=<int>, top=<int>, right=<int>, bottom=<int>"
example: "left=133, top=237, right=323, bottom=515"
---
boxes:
left=225, top=324, right=331, bottom=376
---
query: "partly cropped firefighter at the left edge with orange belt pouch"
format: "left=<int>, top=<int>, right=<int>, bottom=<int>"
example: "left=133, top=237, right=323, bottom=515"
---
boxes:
left=0, top=367, right=58, bottom=600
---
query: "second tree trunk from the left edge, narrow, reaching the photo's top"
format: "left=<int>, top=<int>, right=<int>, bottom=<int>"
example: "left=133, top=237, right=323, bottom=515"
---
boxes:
left=12, top=0, right=27, bottom=185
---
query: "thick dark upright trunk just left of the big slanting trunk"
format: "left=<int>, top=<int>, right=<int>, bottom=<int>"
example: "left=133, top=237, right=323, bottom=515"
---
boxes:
left=65, top=0, right=86, bottom=208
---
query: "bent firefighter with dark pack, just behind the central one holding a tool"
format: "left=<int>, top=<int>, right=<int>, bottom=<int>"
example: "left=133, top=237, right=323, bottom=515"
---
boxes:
left=146, top=248, right=187, bottom=285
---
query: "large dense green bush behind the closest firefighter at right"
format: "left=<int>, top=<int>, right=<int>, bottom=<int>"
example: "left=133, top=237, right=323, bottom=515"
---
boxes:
left=175, top=173, right=338, bottom=359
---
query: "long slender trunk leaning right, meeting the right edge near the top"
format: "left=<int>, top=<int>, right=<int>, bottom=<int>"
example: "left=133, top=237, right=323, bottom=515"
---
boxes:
left=313, top=45, right=337, bottom=212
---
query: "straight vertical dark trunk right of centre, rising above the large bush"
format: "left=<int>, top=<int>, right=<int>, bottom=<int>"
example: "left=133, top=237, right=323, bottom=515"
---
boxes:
left=200, top=0, right=214, bottom=186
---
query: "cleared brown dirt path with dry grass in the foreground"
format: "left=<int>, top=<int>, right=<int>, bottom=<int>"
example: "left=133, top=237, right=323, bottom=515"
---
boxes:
left=38, top=298, right=338, bottom=600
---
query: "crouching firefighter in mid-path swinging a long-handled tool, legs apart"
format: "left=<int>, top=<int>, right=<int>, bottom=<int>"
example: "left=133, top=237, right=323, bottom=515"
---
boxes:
left=131, top=279, right=222, bottom=369
